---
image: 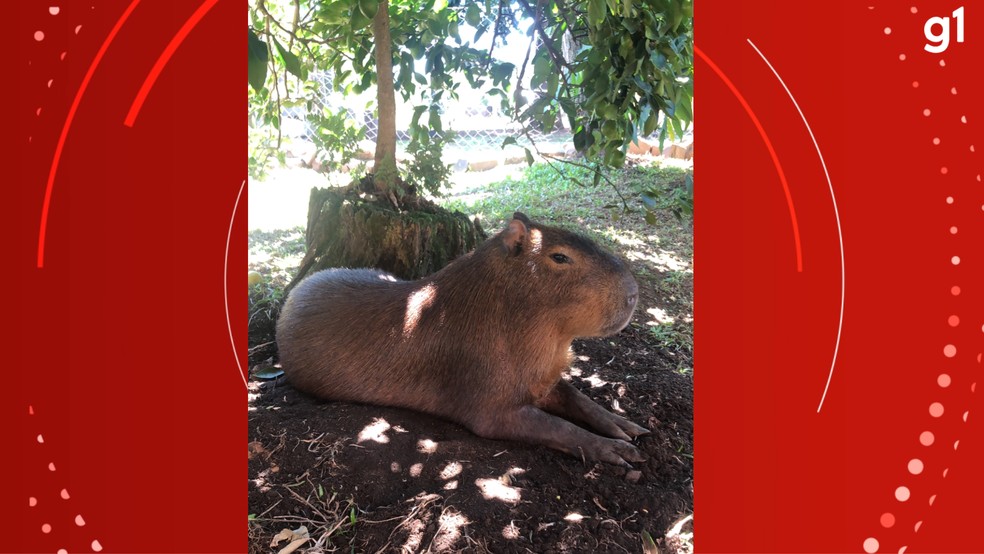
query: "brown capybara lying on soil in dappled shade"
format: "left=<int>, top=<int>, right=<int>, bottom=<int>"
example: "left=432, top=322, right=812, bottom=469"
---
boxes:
left=277, top=212, right=648, bottom=466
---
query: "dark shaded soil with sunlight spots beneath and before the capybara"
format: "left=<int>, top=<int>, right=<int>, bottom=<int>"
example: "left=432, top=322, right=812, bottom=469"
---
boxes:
left=249, top=322, right=693, bottom=553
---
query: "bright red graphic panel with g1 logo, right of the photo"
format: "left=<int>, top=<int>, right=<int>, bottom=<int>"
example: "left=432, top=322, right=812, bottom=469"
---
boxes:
left=694, top=2, right=984, bottom=552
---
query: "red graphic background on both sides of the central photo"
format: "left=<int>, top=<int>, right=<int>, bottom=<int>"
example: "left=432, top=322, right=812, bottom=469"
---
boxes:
left=0, top=0, right=984, bottom=552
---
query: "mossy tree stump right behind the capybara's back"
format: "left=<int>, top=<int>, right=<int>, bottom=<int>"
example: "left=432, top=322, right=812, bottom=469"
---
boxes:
left=287, top=189, right=485, bottom=291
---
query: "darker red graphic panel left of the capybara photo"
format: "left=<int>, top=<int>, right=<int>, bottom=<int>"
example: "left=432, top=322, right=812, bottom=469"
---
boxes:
left=8, top=0, right=247, bottom=553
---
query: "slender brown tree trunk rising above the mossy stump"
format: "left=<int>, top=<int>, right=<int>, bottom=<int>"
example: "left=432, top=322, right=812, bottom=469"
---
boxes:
left=372, top=0, right=402, bottom=197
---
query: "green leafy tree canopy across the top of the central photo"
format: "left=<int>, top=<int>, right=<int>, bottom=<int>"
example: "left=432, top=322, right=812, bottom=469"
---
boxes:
left=249, top=0, right=693, bottom=198
